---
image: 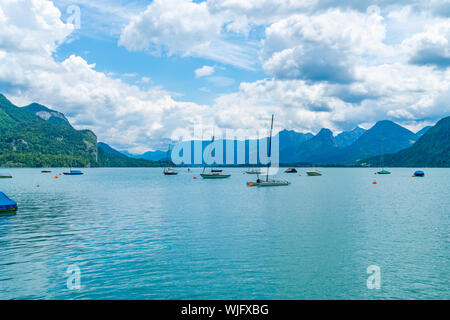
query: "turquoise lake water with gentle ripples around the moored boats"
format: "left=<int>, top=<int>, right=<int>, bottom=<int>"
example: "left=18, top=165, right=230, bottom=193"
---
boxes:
left=0, top=168, right=450, bottom=299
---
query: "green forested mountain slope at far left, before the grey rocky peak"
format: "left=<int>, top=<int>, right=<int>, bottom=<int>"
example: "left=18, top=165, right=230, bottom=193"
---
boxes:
left=0, top=94, right=97, bottom=167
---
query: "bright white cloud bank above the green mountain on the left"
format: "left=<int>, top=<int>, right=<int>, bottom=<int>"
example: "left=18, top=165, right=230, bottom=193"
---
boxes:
left=0, top=0, right=213, bottom=151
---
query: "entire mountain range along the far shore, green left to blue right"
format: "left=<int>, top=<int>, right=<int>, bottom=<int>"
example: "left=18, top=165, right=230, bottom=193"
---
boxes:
left=0, top=94, right=450, bottom=167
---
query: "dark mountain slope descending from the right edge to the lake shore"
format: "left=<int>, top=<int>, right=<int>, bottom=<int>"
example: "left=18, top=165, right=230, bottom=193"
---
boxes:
left=360, top=117, right=450, bottom=167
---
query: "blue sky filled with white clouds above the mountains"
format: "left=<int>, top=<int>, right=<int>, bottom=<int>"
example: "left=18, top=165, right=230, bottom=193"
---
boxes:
left=0, top=0, right=450, bottom=153
